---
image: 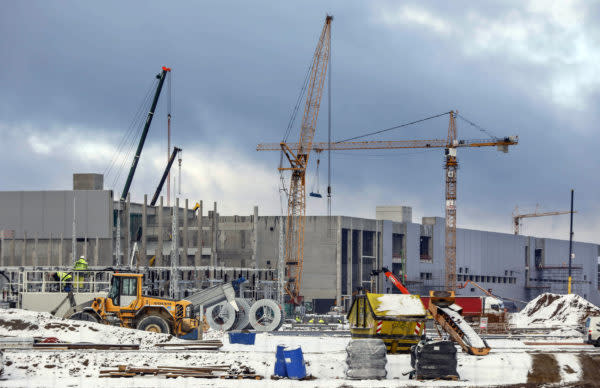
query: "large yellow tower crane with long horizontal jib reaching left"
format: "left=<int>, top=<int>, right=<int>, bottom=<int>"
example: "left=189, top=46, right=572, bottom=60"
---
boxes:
left=256, top=111, right=519, bottom=291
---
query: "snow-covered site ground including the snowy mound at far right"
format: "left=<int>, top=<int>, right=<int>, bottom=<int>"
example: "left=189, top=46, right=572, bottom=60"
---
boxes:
left=0, top=294, right=600, bottom=388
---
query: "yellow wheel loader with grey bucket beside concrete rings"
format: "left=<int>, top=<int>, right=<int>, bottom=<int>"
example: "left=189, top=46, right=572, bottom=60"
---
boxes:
left=64, top=273, right=238, bottom=336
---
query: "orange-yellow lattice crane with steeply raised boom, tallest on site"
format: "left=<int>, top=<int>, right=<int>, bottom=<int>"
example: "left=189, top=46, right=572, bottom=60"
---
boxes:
left=277, top=15, right=333, bottom=304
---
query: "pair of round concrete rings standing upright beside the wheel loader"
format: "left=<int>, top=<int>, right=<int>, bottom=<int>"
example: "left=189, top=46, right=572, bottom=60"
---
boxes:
left=206, top=298, right=284, bottom=331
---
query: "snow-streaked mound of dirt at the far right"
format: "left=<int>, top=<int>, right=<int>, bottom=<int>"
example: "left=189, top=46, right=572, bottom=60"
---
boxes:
left=511, top=293, right=600, bottom=328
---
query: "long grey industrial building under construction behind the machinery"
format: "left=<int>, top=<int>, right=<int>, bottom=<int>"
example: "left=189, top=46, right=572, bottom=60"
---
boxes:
left=0, top=174, right=600, bottom=311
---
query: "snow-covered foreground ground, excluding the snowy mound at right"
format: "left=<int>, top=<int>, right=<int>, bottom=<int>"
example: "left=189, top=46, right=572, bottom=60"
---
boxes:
left=0, top=310, right=600, bottom=387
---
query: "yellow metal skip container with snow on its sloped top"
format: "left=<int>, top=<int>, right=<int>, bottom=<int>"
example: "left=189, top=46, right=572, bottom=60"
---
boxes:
left=347, top=293, right=427, bottom=353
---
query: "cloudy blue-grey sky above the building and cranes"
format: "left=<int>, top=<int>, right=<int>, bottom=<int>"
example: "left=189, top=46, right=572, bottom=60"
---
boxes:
left=0, top=0, right=600, bottom=243
